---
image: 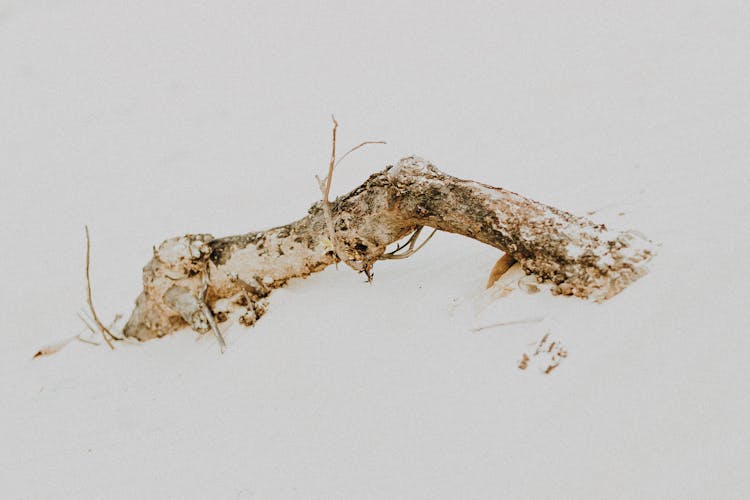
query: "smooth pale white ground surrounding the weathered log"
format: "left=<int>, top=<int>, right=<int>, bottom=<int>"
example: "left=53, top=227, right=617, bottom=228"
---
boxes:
left=0, top=0, right=750, bottom=499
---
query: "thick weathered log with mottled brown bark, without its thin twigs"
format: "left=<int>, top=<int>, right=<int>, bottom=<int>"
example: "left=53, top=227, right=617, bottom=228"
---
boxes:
left=124, top=157, right=652, bottom=340
